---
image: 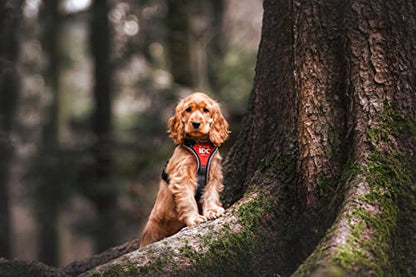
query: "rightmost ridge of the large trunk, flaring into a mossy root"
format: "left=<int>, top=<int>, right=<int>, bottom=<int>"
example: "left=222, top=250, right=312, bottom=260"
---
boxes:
left=295, top=1, right=416, bottom=276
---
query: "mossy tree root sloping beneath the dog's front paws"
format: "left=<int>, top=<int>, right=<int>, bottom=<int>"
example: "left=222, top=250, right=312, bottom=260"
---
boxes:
left=81, top=187, right=282, bottom=276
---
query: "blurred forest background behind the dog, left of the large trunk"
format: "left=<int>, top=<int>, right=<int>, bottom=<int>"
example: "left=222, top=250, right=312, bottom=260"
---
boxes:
left=0, top=0, right=262, bottom=265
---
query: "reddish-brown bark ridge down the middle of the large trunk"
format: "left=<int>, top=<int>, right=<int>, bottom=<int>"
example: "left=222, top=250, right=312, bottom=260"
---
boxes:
left=294, top=0, right=348, bottom=208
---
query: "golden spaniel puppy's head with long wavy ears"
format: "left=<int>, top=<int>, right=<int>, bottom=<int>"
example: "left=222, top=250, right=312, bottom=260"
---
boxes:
left=168, top=92, right=230, bottom=146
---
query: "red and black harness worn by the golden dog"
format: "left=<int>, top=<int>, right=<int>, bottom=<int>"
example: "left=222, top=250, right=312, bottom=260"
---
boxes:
left=162, top=139, right=218, bottom=202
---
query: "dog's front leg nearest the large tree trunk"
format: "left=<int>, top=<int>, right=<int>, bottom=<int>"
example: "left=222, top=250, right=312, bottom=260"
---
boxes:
left=202, top=159, right=224, bottom=219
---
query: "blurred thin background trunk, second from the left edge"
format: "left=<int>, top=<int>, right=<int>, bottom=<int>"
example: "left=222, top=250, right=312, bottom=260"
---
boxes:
left=35, top=0, right=62, bottom=265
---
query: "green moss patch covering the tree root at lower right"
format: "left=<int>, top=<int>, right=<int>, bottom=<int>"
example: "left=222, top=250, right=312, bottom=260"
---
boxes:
left=324, top=151, right=407, bottom=275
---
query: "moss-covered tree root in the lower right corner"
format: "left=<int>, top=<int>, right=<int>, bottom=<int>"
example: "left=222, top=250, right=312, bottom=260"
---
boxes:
left=292, top=151, right=416, bottom=276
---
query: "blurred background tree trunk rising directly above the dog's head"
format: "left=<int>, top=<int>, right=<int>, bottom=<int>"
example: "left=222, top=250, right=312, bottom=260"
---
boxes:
left=166, top=0, right=225, bottom=93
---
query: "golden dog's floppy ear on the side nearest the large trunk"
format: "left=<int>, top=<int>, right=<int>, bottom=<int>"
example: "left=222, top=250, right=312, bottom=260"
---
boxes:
left=209, top=102, right=230, bottom=146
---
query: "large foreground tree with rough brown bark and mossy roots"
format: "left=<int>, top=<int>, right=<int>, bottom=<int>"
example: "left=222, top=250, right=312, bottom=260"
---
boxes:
left=1, top=0, right=416, bottom=276
